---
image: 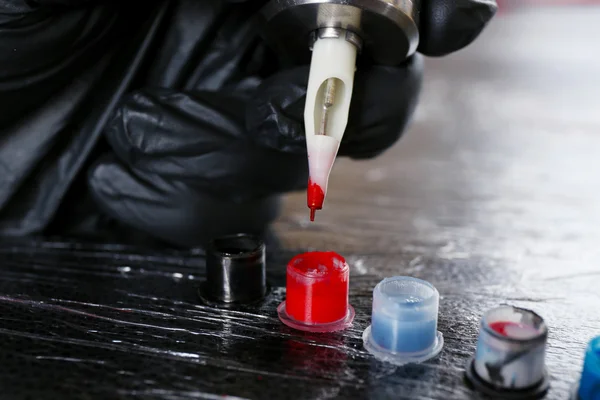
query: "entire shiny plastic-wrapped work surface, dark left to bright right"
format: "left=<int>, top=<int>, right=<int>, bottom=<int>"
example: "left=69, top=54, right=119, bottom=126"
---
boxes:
left=0, top=8, right=600, bottom=400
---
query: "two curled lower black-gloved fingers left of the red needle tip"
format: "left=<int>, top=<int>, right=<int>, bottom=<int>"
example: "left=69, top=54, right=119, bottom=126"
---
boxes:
left=89, top=89, right=308, bottom=246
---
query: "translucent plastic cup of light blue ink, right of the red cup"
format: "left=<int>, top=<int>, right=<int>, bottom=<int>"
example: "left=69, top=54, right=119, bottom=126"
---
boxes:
left=363, top=276, right=444, bottom=365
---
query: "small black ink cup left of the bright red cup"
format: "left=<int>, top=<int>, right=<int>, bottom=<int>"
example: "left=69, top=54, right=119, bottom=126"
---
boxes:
left=199, top=233, right=267, bottom=305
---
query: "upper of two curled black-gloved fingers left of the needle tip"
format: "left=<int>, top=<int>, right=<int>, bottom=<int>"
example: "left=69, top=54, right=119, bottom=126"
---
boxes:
left=106, top=89, right=307, bottom=202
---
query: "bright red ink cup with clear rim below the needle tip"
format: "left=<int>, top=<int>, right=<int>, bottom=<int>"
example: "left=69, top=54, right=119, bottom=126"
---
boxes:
left=277, top=252, right=354, bottom=332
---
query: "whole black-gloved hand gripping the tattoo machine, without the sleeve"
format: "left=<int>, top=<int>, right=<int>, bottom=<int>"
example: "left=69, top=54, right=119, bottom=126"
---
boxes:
left=89, top=0, right=496, bottom=245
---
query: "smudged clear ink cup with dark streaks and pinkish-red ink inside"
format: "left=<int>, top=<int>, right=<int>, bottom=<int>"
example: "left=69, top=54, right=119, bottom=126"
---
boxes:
left=466, top=306, right=549, bottom=399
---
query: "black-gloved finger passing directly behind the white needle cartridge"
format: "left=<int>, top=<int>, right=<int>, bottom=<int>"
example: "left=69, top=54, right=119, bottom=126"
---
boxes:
left=246, top=55, right=422, bottom=158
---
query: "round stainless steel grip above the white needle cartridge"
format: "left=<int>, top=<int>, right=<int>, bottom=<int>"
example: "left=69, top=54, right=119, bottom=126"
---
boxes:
left=261, top=0, right=420, bottom=65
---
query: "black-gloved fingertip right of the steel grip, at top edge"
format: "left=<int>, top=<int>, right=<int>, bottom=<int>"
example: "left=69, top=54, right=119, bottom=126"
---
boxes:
left=419, top=0, right=498, bottom=56
